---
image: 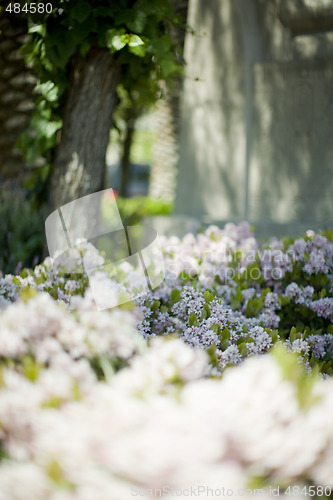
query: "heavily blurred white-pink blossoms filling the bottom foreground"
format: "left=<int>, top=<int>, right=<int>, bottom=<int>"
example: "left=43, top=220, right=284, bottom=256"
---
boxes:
left=0, top=326, right=333, bottom=500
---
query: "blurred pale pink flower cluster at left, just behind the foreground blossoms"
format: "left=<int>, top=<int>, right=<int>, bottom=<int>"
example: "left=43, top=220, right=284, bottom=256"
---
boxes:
left=0, top=292, right=142, bottom=364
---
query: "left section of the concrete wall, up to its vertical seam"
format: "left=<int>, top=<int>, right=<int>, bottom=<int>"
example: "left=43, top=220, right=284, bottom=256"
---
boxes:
left=176, top=0, right=244, bottom=217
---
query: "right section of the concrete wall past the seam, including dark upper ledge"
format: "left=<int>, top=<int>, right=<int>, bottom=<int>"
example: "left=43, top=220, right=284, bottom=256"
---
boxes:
left=244, top=0, right=333, bottom=226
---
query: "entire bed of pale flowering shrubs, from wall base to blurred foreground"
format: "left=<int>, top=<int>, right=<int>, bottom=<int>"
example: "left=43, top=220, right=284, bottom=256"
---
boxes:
left=0, top=224, right=333, bottom=494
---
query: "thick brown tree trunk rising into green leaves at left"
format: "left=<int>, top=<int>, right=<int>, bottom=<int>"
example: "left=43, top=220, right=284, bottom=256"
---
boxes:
left=49, top=48, right=120, bottom=211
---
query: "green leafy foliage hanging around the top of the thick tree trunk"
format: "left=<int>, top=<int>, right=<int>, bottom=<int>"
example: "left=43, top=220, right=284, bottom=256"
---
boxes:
left=19, top=0, right=182, bottom=191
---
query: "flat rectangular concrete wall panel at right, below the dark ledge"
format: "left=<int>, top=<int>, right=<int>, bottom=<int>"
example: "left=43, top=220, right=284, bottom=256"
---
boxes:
left=250, top=61, right=333, bottom=223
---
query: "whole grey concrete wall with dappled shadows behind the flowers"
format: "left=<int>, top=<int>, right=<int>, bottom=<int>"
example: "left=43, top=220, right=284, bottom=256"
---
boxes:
left=172, top=0, right=333, bottom=234
